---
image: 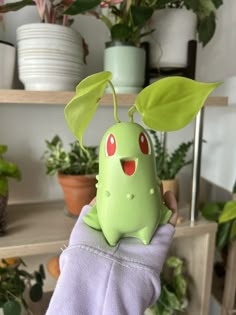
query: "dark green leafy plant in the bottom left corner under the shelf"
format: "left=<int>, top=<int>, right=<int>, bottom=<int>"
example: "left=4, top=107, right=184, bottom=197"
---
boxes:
left=0, top=259, right=45, bottom=315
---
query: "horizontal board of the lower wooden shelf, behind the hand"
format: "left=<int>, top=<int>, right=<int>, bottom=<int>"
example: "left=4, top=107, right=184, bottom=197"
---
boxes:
left=0, top=201, right=216, bottom=258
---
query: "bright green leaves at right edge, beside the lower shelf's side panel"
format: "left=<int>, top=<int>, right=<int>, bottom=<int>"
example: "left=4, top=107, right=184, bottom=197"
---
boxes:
left=201, top=200, right=236, bottom=250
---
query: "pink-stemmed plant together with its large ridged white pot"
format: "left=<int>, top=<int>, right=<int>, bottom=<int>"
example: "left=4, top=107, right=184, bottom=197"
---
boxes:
left=0, top=0, right=97, bottom=90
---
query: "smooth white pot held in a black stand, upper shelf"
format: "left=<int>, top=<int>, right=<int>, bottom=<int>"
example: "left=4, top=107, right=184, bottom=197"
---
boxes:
left=149, top=8, right=197, bottom=68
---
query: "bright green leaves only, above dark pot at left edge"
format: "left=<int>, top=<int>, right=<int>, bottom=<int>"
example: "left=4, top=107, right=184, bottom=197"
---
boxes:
left=0, top=145, right=21, bottom=197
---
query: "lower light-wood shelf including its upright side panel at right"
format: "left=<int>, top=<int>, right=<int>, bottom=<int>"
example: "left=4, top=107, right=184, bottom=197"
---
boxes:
left=0, top=201, right=217, bottom=315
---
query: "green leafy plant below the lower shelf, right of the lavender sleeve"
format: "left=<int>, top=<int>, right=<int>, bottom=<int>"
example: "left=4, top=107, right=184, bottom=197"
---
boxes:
left=152, top=256, right=188, bottom=315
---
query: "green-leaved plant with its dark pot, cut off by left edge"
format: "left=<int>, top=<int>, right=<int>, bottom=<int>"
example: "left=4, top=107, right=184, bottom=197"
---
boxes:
left=0, top=144, right=21, bottom=235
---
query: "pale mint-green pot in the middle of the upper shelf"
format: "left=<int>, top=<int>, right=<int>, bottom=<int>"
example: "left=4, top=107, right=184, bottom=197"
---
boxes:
left=104, top=42, right=146, bottom=94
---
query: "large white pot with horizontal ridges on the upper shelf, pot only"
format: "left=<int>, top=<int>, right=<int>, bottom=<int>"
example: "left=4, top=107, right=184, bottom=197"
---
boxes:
left=17, top=23, right=84, bottom=91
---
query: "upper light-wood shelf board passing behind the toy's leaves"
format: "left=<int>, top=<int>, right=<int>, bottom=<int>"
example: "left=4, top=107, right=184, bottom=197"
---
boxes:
left=0, top=90, right=228, bottom=106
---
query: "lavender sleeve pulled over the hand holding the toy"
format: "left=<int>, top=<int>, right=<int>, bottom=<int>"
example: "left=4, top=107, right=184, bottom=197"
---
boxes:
left=46, top=206, right=175, bottom=315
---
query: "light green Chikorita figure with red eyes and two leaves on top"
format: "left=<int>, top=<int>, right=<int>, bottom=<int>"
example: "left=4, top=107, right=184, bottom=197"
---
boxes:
left=65, top=72, right=221, bottom=246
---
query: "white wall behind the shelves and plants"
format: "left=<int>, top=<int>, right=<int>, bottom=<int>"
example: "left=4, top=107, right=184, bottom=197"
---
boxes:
left=0, top=0, right=236, bottom=202
